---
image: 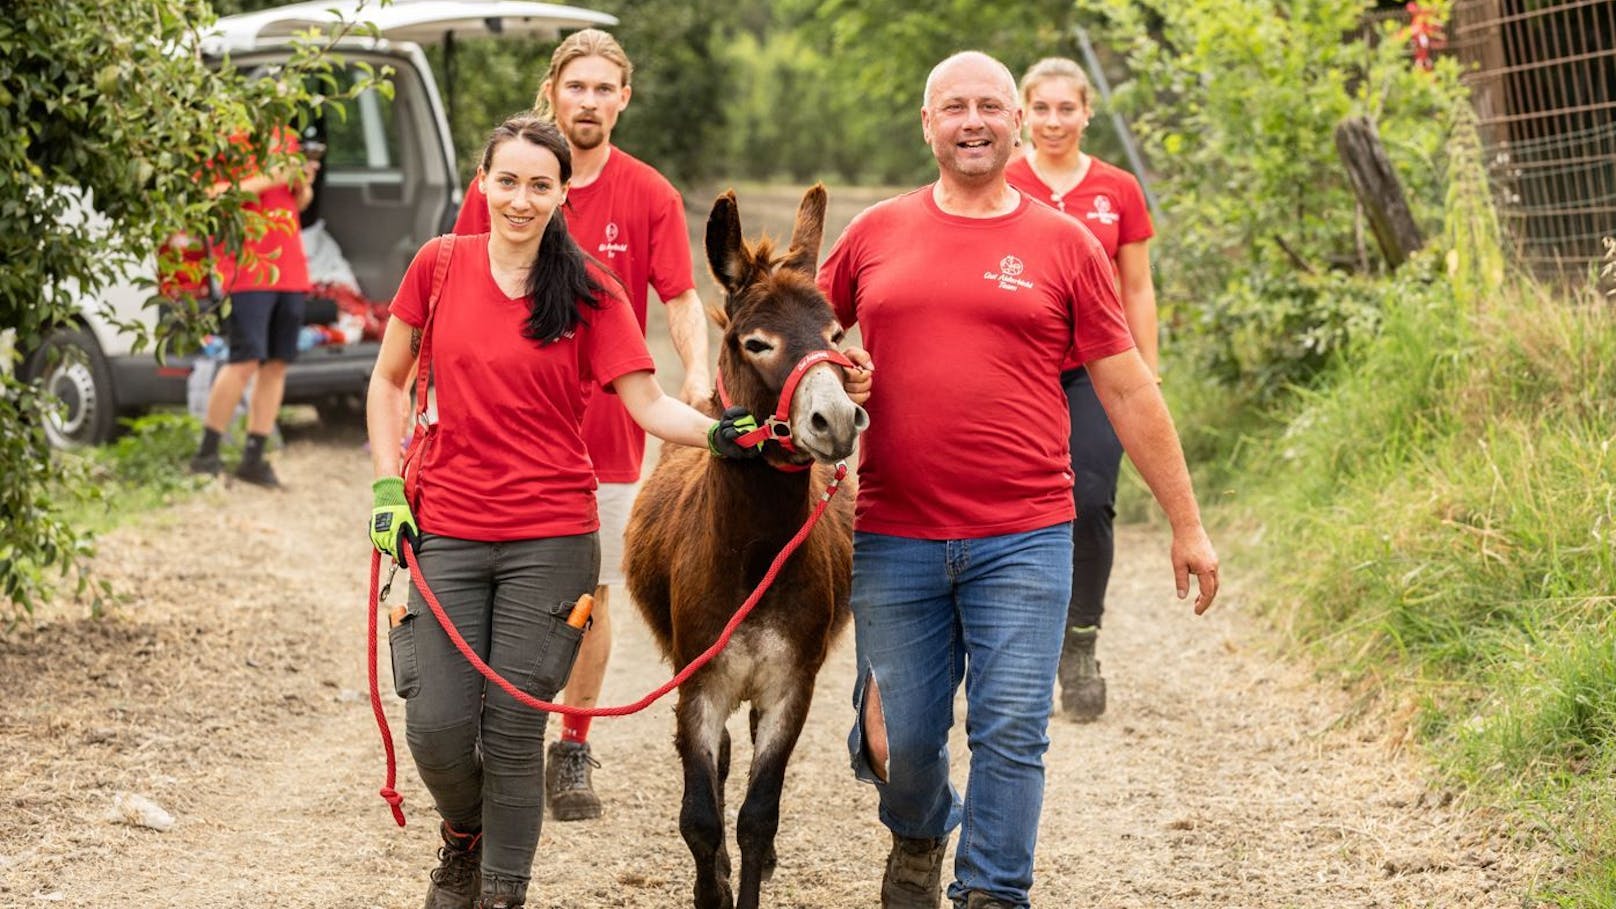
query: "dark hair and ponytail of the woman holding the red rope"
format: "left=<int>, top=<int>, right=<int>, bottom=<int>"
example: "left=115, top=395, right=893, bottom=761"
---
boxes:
left=483, top=116, right=606, bottom=345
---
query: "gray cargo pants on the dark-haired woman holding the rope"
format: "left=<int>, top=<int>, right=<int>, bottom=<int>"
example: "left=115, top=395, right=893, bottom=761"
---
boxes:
left=388, top=534, right=600, bottom=882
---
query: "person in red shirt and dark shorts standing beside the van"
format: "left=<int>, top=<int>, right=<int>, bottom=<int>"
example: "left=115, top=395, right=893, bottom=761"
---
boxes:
left=191, top=129, right=309, bottom=488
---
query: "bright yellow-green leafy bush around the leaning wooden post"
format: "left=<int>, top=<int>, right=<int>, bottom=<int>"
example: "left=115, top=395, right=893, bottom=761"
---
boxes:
left=1078, top=0, right=1462, bottom=396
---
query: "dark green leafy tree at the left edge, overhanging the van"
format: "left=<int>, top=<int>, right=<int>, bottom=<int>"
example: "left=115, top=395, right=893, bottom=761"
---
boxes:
left=0, top=0, right=381, bottom=607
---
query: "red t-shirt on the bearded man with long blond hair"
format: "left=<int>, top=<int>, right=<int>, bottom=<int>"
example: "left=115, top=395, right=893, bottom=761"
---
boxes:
left=454, top=146, right=696, bottom=484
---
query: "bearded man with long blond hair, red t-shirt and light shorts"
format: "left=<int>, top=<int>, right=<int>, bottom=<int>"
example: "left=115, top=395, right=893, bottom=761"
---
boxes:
left=454, top=29, right=713, bottom=820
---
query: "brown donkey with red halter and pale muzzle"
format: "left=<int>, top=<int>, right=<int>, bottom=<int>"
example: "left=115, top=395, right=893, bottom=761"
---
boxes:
left=624, top=184, right=869, bottom=909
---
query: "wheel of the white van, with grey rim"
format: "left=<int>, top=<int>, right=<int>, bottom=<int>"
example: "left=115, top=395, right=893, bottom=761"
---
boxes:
left=23, top=328, right=118, bottom=448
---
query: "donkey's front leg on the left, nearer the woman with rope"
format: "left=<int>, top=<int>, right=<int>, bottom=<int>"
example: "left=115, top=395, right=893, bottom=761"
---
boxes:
left=674, top=685, right=734, bottom=909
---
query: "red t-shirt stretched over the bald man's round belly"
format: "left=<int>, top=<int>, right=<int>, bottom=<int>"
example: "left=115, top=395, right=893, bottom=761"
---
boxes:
left=819, top=186, right=1133, bottom=540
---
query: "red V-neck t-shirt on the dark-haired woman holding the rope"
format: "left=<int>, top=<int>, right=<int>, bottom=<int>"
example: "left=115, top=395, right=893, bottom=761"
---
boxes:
left=393, top=235, right=654, bottom=542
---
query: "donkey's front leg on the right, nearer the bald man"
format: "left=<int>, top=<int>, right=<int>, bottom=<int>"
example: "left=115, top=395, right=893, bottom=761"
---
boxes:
left=735, top=676, right=813, bottom=909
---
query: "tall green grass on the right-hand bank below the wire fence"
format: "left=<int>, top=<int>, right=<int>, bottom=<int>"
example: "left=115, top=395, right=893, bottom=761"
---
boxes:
left=1221, top=250, right=1616, bottom=906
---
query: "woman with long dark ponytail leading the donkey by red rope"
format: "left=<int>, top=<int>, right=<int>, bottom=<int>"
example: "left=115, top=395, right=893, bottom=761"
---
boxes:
left=367, top=116, right=756, bottom=909
